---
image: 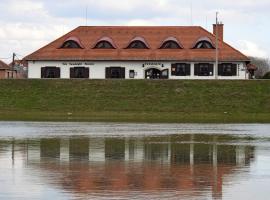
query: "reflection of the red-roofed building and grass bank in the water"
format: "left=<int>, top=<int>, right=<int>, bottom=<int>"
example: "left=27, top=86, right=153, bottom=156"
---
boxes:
left=0, top=135, right=254, bottom=198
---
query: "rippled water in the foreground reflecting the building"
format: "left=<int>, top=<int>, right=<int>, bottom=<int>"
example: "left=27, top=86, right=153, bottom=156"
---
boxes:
left=0, top=122, right=270, bottom=200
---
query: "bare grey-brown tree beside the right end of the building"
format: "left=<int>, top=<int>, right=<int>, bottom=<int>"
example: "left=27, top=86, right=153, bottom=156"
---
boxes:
left=250, top=57, right=270, bottom=78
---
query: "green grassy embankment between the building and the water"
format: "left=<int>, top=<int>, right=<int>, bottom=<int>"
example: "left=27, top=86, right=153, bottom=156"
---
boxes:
left=0, top=80, right=270, bottom=123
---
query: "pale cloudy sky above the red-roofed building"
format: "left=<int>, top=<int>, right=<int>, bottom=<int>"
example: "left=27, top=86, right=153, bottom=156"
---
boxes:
left=0, top=0, right=270, bottom=62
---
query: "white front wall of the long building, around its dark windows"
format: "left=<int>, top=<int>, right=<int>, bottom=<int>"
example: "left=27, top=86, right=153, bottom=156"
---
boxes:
left=28, top=61, right=248, bottom=80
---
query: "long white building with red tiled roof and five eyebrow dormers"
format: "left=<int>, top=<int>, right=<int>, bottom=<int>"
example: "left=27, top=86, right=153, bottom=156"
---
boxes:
left=25, top=24, right=252, bottom=79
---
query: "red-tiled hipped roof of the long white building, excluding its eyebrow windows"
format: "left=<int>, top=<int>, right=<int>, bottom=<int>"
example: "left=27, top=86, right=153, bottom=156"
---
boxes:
left=25, top=26, right=249, bottom=61
